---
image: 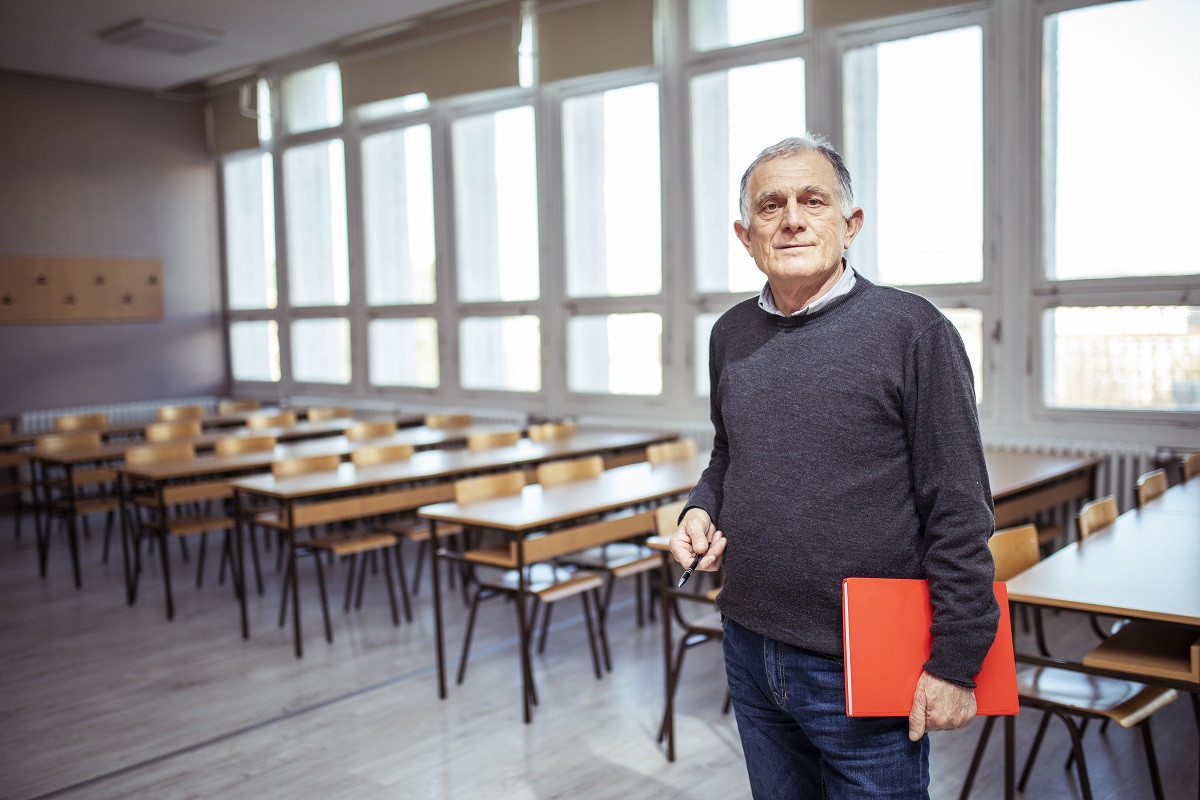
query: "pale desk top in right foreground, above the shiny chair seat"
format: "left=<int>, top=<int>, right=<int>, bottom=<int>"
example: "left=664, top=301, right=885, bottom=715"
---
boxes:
left=1008, top=510, right=1200, bottom=626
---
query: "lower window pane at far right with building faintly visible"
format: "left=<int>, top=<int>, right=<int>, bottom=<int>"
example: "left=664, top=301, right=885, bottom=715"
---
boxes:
left=1042, top=306, right=1200, bottom=411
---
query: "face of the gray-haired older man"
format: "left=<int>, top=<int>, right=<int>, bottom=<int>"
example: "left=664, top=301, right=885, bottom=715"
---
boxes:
left=733, top=152, right=863, bottom=290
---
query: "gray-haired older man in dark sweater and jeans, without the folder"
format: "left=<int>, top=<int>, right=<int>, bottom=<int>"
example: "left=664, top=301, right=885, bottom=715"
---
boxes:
left=671, top=134, right=1000, bottom=800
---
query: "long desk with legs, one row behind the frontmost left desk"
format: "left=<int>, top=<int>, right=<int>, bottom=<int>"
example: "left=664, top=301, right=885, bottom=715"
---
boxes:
left=230, top=431, right=672, bottom=658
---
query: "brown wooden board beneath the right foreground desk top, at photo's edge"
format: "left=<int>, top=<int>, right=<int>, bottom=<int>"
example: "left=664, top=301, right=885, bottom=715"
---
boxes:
left=1084, top=620, right=1200, bottom=681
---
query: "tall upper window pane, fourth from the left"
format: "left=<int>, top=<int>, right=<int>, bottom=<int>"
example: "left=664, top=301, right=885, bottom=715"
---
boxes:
left=452, top=106, right=539, bottom=302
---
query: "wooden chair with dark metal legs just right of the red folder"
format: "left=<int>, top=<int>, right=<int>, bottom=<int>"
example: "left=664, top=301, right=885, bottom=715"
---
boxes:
left=960, top=525, right=1177, bottom=800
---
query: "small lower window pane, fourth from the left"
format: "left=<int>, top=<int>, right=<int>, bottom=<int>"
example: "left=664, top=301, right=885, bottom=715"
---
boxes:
left=458, top=317, right=541, bottom=392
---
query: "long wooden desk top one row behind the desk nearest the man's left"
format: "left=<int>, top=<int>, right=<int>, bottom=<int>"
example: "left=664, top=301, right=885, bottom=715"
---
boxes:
left=225, top=431, right=676, bottom=500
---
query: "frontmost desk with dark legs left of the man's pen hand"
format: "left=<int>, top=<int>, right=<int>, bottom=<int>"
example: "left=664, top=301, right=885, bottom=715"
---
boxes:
left=419, top=453, right=708, bottom=723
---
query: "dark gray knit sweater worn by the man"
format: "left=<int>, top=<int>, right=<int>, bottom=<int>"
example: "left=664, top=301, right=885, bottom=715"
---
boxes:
left=689, top=275, right=1000, bottom=687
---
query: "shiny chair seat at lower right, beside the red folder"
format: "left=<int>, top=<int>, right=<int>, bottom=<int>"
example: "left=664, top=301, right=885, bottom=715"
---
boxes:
left=1016, top=667, right=1177, bottom=728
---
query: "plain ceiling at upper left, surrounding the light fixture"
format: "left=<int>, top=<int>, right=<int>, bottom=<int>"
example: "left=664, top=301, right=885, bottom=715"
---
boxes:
left=0, top=0, right=477, bottom=94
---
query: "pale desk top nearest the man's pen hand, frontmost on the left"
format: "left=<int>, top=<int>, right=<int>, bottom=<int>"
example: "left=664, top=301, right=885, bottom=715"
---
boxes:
left=419, top=453, right=708, bottom=533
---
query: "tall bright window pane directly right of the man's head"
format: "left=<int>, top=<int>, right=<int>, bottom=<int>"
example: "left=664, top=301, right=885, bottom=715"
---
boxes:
left=845, top=26, right=983, bottom=284
